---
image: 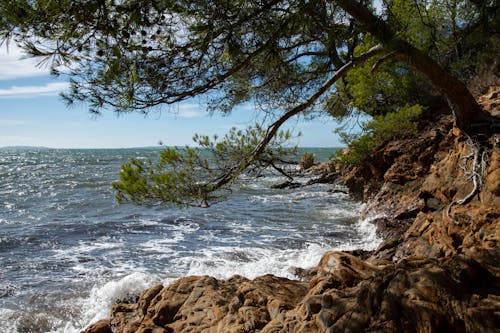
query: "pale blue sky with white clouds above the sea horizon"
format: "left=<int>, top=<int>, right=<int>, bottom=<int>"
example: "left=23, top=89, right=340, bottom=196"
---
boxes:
left=0, top=45, right=342, bottom=148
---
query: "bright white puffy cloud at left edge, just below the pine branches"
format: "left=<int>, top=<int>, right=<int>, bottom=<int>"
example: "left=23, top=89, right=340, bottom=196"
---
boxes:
left=0, top=43, right=50, bottom=80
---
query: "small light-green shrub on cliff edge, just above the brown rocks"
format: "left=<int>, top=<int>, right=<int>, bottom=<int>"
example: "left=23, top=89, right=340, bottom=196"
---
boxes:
left=337, top=104, right=424, bottom=164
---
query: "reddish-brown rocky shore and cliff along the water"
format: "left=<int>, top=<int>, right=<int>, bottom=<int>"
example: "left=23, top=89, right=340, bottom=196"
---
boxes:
left=84, top=91, right=500, bottom=333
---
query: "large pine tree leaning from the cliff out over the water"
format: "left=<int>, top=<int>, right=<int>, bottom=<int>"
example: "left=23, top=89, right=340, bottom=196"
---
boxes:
left=0, top=0, right=498, bottom=204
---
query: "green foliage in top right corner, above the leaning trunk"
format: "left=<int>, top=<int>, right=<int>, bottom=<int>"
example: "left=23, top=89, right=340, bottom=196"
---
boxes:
left=387, top=0, right=500, bottom=88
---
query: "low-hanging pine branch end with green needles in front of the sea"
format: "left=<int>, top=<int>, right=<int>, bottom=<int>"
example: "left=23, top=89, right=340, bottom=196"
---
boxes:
left=113, top=125, right=297, bottom=206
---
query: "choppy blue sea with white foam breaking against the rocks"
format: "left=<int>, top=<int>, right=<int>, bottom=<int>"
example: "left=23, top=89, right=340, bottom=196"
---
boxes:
left=0, top=148, right=379, bottom=333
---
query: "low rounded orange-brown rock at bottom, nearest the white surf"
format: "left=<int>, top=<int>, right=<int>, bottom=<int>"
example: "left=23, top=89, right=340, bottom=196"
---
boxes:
left=103, top=275, right=307, bottom=333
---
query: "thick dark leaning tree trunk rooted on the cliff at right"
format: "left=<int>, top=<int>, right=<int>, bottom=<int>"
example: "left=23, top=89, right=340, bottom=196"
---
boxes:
left=336, top=0, right=499, bottom=136
